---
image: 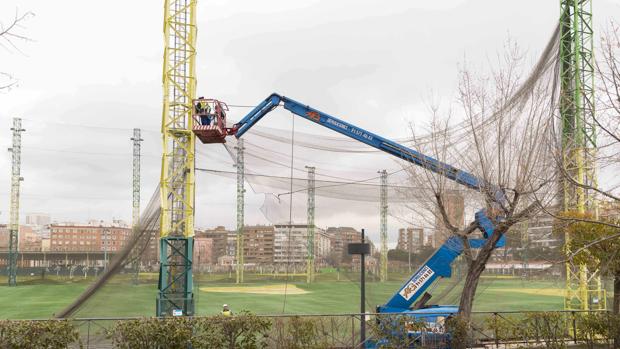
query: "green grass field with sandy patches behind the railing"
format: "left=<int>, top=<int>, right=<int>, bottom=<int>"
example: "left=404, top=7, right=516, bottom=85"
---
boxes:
left=0, top=275, right=563, bottom=319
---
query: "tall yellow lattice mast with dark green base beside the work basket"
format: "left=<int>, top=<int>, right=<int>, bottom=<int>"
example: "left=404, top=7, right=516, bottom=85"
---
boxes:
left=157, top=0, right=196, bottom=316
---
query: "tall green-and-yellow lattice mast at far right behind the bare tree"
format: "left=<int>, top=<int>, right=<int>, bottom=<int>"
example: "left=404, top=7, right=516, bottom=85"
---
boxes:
left=560, top=0, right=606, bottom=310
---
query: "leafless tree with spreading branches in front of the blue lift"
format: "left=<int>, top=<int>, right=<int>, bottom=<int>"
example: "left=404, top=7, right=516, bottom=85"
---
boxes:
left=407, top=40, right=556, bottom=328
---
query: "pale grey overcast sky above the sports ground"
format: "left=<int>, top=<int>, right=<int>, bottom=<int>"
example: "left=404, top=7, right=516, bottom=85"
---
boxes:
left=0, top=0, right=620, bottom=245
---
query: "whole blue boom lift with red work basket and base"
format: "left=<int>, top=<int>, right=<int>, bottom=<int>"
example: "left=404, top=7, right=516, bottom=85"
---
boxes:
left=194, top=93, right=505, bottom=348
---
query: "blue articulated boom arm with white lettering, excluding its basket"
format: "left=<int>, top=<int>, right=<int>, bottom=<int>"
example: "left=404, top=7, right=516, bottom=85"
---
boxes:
left=230, top=93, right=504, bottom=312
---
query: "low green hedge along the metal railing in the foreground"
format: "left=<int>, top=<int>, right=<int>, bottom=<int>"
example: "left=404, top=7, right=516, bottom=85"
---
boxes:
left=0, top=312, right=620, bottom=349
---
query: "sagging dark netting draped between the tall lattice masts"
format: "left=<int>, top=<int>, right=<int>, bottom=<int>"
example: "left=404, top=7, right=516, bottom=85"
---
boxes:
left=57, top=26, right=559, bottom=317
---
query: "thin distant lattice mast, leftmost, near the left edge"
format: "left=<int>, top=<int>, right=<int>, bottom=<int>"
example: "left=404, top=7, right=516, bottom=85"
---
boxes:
left=8, top=118, right=26, bottom=286
